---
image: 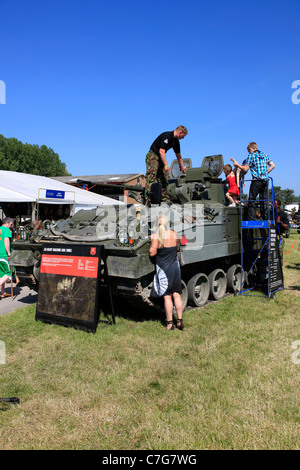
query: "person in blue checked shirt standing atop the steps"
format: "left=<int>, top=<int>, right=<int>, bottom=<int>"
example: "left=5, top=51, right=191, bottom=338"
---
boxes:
left=232, top=142, right=275, bottom=220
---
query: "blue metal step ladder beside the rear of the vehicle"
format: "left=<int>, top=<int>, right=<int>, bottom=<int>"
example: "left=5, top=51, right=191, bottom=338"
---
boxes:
left=239, top=177, right=284, bottom=298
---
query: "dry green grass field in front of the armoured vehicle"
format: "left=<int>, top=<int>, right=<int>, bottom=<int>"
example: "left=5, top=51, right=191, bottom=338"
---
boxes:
left=0, top=233, right=300, bottom=450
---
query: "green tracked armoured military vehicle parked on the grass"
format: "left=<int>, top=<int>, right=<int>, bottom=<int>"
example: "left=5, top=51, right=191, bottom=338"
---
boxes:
left=10, top=155, right=241, bottom=314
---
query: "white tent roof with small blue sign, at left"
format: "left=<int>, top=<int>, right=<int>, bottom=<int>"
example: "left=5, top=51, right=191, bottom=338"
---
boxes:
left=0, top=170, right=123, bottom=212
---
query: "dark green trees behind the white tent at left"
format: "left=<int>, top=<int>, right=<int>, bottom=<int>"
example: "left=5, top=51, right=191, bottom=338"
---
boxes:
left=0, top=134, right=70, bottom=177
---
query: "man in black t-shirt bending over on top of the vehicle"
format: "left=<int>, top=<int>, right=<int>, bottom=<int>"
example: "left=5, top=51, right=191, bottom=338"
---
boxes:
left=146, top=126, right=188, bottom=201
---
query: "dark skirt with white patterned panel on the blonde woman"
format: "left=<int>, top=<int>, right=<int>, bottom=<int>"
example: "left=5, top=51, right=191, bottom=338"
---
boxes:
left=151, top=246, right=182, bottom=297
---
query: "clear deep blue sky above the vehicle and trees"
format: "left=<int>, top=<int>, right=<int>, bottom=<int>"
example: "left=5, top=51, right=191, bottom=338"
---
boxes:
left=0, top=0, right=300, bottom=196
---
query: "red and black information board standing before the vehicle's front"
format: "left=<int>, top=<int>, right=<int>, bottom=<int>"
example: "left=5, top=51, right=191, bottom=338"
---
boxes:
left=36, top=244, right=104, bottom=331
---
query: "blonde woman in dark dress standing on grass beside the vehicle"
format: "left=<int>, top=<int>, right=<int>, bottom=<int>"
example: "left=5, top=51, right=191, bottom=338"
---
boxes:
left=149, top=215, right=184, bottom=330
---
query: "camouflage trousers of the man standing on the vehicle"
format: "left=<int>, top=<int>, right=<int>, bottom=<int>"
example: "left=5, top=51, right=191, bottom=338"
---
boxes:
left=146, top=150, right=170, bottom=201
